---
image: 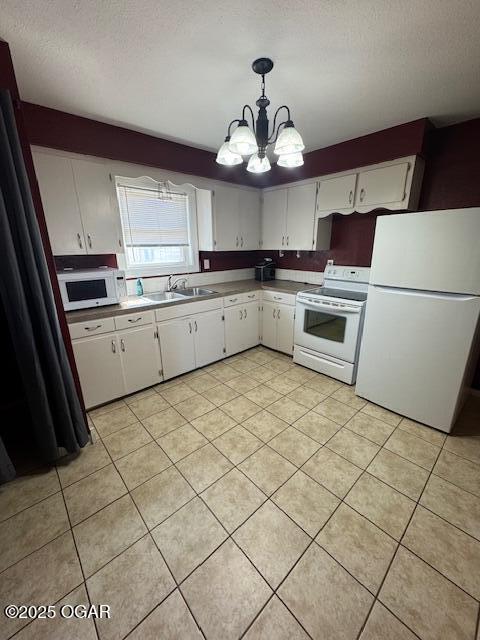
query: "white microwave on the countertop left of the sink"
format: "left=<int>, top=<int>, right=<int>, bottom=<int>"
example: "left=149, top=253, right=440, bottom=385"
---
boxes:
left=57, top=267, right=127, bottom=311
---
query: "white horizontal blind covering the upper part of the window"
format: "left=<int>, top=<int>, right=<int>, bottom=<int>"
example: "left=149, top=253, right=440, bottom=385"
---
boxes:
left=117, top=183, right=189, bottom=247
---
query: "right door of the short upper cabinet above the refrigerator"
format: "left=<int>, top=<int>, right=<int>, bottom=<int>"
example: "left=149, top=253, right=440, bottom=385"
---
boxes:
left=356, top=162, right=410, bottom=208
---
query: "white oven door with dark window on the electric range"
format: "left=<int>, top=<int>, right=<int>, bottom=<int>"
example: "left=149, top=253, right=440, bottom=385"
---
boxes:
left=295, top=299, right=362, bottom=363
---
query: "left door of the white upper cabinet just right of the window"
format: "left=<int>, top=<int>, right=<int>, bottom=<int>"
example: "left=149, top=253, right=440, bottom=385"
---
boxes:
left=213, top=187, right=240, bottom=251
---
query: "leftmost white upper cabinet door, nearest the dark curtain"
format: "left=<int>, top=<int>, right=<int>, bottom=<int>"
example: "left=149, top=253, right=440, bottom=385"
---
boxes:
left=33, top=151, right=86, bottom=255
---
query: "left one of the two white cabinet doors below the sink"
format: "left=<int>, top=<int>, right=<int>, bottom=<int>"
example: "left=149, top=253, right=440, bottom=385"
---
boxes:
left=157, top=318, right=195, bottom=380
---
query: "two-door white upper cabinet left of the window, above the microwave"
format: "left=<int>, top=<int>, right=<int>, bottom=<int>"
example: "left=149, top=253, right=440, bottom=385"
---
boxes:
left=32, top=149, right=123, bottom=255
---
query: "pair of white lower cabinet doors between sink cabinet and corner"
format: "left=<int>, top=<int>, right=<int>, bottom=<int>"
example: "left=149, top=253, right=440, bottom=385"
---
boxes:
left=225, top=302, right=259, bottom=356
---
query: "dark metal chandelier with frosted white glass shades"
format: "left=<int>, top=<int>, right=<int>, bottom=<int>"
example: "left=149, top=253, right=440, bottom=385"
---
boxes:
left=216, top=58, right=305, bottom=173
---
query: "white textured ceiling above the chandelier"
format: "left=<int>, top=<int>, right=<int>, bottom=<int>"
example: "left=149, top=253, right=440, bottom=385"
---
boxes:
left=0, top=0, right=480, bottom=150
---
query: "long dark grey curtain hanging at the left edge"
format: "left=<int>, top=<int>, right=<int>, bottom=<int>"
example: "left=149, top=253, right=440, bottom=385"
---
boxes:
left=0, top=90, right=89, bottom=482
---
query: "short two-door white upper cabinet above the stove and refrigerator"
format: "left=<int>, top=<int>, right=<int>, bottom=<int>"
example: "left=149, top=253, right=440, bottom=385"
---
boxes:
left=317, top=156, right=424, bottom=218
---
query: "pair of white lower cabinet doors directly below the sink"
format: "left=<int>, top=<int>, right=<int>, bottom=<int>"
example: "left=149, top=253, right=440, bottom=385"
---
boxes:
left=158, top=309, right=225, bottom=380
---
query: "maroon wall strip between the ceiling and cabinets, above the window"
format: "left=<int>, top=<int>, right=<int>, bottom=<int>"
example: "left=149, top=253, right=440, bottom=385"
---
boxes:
left=22, top=102, right=257, bottom=186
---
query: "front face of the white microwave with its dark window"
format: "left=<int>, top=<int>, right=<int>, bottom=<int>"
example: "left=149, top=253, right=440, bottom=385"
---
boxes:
left=58, top=273, right=118, bottom=311
